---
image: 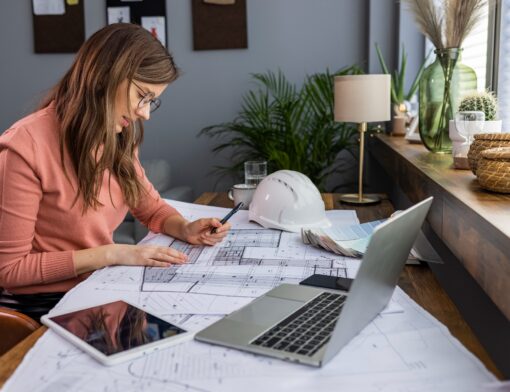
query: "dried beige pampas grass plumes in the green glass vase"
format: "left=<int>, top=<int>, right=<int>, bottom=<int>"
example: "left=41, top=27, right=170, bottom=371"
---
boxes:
left=403, top=0, right=487, bottom=49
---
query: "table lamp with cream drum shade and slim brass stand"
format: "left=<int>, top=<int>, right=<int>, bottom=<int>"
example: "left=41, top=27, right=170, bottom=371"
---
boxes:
left=335, top=75, right=391, bottom=204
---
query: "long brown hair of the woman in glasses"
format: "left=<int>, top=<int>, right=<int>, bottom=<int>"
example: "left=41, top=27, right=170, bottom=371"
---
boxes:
left=42, top=23, right=178, bottom=213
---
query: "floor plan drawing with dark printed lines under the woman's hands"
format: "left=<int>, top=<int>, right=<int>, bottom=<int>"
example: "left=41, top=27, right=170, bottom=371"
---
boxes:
left=141, top=229, right=347, bottom=297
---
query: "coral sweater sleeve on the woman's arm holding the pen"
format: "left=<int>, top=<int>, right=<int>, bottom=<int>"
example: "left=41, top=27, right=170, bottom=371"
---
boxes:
left=131, top=154, right=180, bottom=233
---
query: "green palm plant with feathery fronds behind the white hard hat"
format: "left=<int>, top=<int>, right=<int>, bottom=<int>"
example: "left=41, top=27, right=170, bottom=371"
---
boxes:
left=200, top=66, right=363, bottom=191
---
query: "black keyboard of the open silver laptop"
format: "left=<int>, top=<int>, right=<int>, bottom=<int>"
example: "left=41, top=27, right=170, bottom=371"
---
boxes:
left=250, top=292, right=347, bottom=356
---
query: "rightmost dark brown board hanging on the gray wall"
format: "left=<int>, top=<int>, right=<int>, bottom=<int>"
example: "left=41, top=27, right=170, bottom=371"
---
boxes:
left=192, top=0, right=248, bottom=50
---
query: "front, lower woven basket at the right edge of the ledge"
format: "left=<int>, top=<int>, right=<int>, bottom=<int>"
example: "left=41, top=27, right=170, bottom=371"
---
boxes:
left=476, top=147, right=510, bottom=193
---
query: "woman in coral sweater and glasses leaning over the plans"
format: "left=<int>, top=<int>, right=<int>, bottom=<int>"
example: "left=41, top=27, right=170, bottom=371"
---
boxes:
left=0, top=24, right=230, bottom=317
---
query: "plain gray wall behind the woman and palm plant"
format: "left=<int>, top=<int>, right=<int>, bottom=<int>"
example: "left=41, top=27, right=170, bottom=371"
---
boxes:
left=0, top=0, right=422, bottom=195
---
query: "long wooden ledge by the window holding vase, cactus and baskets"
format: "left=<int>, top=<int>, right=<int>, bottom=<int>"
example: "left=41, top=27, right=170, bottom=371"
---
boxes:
left=370, top=135, right=510, bottom=320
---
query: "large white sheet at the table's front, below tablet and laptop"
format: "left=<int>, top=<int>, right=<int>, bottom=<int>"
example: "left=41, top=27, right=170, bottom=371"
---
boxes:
left=5, top=289, right=496, bottom=392
